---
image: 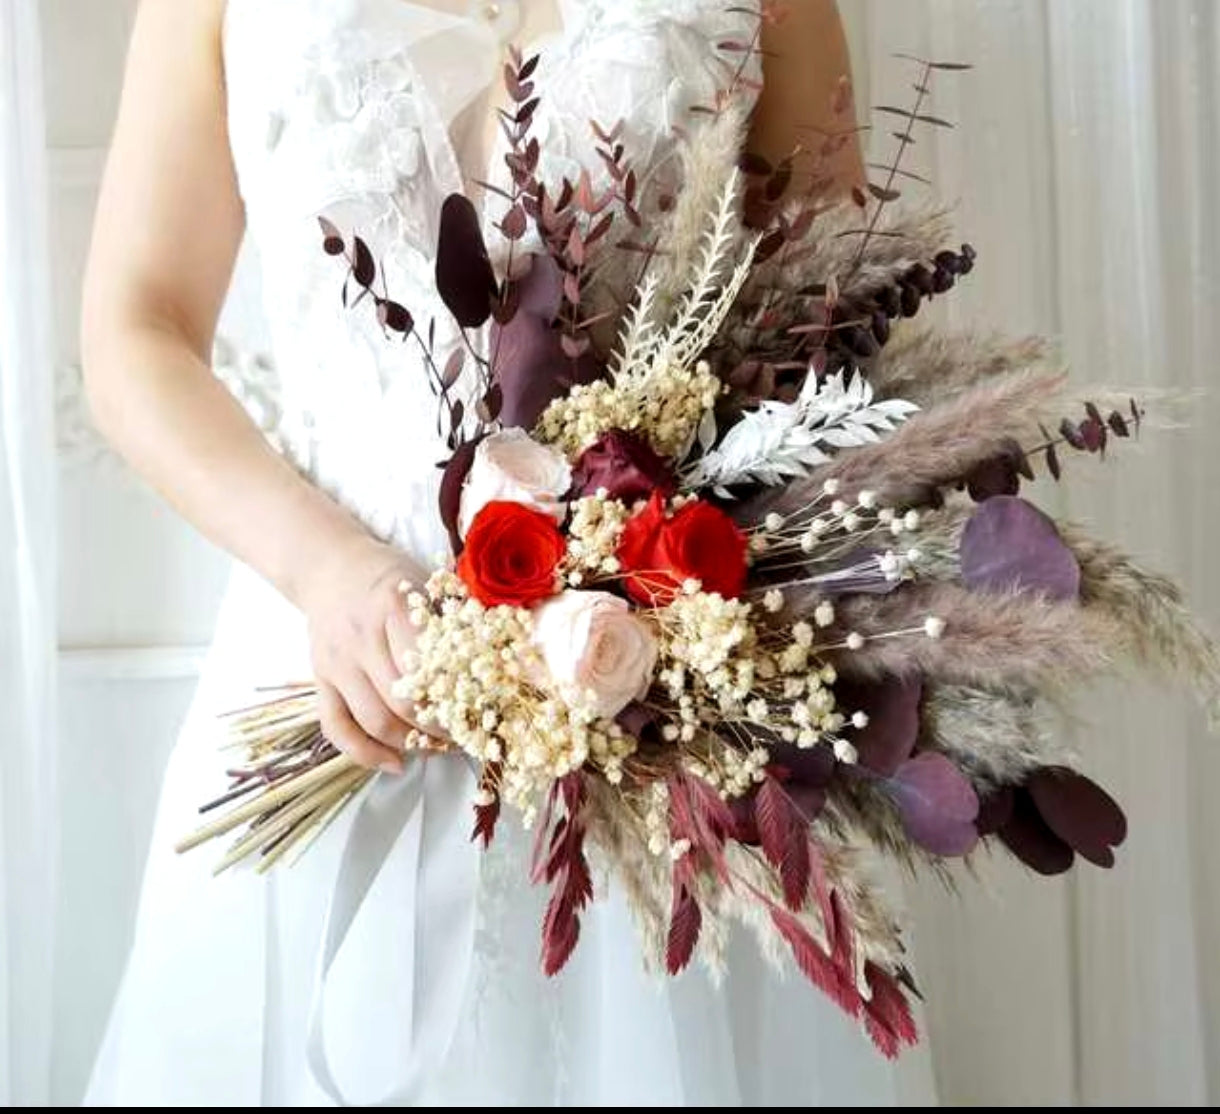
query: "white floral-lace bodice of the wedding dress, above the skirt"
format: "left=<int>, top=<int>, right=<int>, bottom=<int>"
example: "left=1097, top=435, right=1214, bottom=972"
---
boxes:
left=224, top=0, right=752, bottom=561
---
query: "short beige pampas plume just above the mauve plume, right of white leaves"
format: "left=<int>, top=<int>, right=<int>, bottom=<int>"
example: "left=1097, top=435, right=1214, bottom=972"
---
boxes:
left=869, top=325, right=1049, bottom=408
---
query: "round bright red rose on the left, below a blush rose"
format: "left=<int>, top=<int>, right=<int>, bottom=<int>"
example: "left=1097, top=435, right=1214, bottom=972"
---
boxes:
left=458, top=500, right=565, bottom=608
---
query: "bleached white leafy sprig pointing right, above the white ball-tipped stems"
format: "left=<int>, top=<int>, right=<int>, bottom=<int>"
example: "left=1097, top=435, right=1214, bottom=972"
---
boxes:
left=682, top=372, right=919, bottom=490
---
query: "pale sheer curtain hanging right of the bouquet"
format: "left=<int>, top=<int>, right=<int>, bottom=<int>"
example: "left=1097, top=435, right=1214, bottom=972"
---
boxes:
left=841, top=0, right=1220, bottom=1104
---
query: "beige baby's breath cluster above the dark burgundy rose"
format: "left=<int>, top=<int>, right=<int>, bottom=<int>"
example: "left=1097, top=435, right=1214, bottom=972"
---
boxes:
left=534, top=359, right=721, bottom=456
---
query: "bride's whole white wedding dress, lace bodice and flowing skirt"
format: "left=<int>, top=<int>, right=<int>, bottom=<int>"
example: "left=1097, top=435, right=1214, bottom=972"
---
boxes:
left=87, top=0, right=931, bottom=1105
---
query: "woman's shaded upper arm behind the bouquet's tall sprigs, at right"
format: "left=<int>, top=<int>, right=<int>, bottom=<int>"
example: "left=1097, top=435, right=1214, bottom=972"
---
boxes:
left=749, top=0, right=865, bottom=193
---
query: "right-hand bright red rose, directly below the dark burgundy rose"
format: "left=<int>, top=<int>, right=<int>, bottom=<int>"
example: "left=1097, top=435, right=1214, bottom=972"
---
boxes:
left=619, top=493, right=747, bottom=606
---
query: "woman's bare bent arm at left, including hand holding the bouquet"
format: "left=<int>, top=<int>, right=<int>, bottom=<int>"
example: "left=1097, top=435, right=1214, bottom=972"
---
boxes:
left=82, top=0, right=417, bottom=769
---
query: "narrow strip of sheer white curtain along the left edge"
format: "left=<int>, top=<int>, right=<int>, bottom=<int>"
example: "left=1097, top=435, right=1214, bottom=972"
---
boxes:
left=0, top=0, right=57, bottom=1105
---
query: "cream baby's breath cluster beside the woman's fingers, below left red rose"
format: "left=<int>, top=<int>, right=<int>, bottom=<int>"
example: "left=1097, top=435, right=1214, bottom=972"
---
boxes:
left=399, top=585, right=636, bottom=822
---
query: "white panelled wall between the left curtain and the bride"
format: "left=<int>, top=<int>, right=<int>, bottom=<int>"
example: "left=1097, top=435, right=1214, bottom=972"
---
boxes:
left=41, top=0, right=228, bottom=1104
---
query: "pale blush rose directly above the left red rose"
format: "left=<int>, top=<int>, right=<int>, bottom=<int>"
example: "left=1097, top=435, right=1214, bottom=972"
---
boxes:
left=458, top=429, right=572, bottom=537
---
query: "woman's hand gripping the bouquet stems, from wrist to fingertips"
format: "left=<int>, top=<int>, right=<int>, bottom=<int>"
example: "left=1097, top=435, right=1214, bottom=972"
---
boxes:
left=300, top=537, right=422, bottom=774
